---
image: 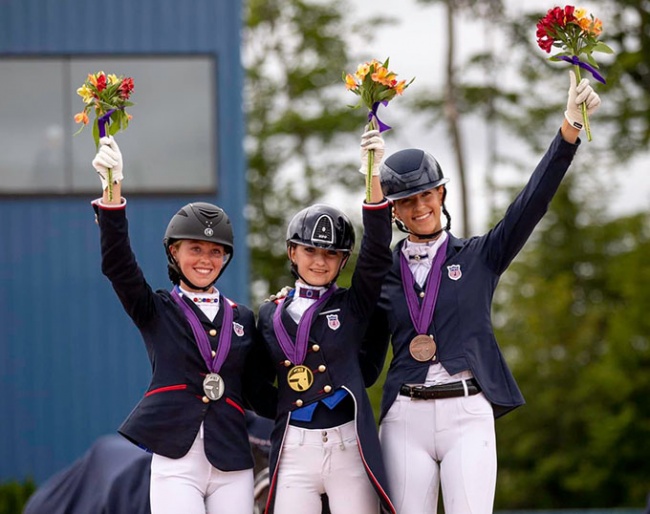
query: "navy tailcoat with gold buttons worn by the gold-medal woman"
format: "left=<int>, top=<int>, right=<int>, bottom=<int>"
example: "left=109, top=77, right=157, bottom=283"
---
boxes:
left=254, top=205, right=394, bottom=514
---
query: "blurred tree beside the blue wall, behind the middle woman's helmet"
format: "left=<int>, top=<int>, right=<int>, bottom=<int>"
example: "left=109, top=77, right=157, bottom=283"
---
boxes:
left=244, top=0, right=390, bottom=303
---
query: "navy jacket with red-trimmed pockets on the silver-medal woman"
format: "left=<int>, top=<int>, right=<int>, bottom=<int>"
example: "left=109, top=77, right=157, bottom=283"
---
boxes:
left=93, top=201, right=256, bottom=471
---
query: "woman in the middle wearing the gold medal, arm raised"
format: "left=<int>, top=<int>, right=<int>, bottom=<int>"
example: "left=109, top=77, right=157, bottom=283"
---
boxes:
left=253, top=130, right=395, bottom=514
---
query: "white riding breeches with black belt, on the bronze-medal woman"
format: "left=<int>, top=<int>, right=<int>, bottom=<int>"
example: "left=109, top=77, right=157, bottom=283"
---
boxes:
left=379, top=393, right=497, bottom=514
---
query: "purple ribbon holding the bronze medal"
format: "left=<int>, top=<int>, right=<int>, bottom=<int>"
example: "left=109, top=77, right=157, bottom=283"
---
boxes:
left=399, top=238, right=449, bottom=334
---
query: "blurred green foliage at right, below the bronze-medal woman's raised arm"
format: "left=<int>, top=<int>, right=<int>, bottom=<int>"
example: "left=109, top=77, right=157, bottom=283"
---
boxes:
left=494, top=179, right=650, bottom=508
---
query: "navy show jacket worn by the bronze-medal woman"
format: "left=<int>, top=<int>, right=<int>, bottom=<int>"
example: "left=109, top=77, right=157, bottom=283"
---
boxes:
left=366, top=134, right=579, bottom=418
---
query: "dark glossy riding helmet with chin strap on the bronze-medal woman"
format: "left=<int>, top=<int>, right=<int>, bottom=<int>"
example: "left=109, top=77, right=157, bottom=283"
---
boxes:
left=379, top=148, right=451, bottom=239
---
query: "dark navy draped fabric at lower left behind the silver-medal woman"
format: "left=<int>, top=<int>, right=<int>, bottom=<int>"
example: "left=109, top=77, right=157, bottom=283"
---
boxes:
left=23, top=435, right=151, bottom=514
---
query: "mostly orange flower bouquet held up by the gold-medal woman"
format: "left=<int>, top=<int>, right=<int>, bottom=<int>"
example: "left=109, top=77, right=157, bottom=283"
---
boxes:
left=343, top=59, right=415, bottom=201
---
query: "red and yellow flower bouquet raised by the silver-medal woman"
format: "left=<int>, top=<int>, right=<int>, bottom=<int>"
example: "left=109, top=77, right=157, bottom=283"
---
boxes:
left=74, top=71, right=133, bottom=200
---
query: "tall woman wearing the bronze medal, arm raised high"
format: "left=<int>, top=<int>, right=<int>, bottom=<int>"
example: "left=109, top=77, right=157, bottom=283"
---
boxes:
left=367, top=71, right=600, bottom=514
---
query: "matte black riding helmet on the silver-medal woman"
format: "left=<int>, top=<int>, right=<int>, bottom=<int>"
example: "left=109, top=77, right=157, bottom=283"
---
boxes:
left=163, top=202, right=234, bottom=291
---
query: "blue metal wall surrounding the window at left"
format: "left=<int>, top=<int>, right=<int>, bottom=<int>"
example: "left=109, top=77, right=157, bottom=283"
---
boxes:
left=0, top=0, right=248, bottom=482
